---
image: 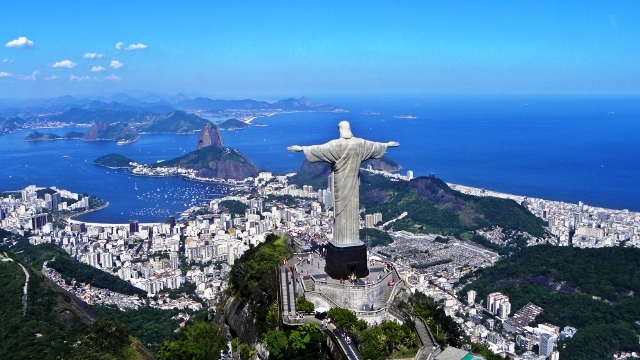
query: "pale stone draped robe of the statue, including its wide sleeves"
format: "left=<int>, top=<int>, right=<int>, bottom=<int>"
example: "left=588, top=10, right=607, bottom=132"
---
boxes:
left=302, top=137, right=387, bottom=246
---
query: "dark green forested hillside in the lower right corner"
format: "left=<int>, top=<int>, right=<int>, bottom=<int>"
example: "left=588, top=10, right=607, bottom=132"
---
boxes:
left=461, top=245, right=640, bottom=359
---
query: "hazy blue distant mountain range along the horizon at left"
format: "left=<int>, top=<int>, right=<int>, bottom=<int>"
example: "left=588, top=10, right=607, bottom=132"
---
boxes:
left=0, top=93, right=347, bottom=140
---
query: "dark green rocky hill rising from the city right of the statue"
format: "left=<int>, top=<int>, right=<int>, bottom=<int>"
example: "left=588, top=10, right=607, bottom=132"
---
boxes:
left=360, top=173, right=544, bottom=237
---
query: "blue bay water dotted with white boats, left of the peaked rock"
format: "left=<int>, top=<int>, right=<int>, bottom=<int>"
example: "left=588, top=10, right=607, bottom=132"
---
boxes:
left=0, top=128, right=225, bottom=223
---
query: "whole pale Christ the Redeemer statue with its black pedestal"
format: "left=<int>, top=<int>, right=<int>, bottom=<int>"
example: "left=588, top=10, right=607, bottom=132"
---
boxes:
left=287, top=121, right=400, bottom=279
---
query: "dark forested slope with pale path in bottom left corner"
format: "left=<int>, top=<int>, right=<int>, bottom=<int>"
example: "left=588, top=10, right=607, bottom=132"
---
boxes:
left=0, top=252, right=152, bottom=359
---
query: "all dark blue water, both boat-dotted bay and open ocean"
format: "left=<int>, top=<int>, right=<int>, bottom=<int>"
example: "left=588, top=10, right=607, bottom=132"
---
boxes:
left=0, top=97, right=640, bottom=221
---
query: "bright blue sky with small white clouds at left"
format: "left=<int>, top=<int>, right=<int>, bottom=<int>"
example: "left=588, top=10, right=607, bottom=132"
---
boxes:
left=0, top=0, right=640, bottom=99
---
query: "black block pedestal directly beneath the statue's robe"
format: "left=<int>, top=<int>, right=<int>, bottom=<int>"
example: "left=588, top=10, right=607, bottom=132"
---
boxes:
left=325, top=241, right=369, bottom=280
